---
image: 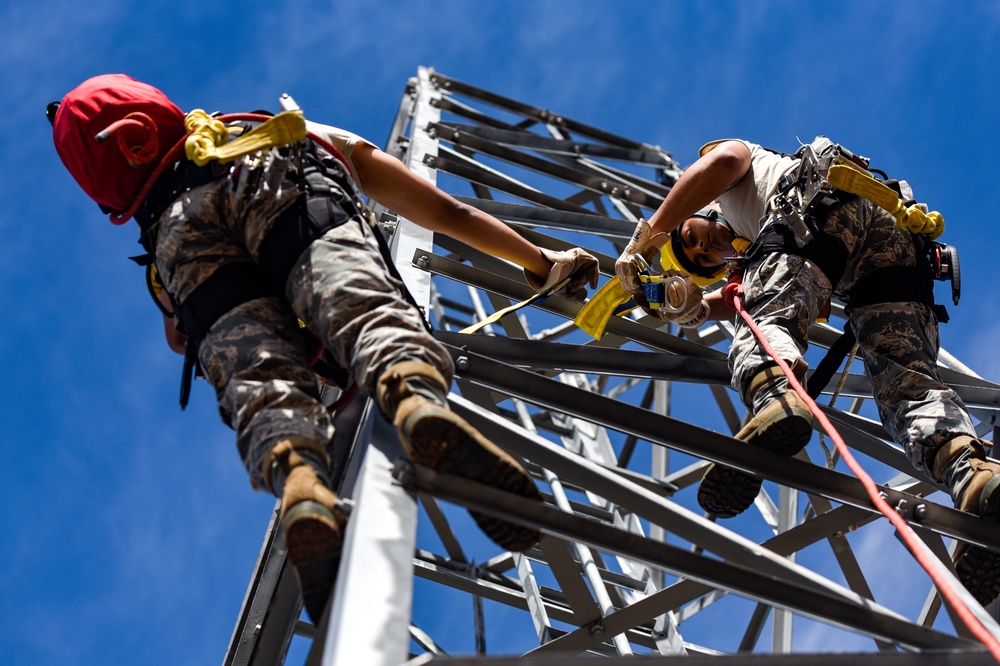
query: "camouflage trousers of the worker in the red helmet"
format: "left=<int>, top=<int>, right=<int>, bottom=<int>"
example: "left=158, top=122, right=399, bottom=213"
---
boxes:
left=157, top=169, right=454, bottom=487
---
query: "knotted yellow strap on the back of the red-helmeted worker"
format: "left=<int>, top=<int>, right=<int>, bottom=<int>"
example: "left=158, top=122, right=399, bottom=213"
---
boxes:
left=184, top=109, right=306, bottom=166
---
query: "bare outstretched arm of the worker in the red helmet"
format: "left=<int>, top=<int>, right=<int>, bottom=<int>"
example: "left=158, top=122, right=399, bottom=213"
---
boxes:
left=351, top=143, right=552, bottom=276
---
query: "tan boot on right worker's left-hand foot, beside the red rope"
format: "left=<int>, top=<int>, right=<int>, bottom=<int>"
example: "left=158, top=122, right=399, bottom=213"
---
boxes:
left=698, top=368, right=812, bottom=518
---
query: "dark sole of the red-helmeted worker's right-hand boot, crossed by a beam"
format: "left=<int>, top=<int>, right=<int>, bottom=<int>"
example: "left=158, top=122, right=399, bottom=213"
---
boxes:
left=402, top=405, right=542, bottom=551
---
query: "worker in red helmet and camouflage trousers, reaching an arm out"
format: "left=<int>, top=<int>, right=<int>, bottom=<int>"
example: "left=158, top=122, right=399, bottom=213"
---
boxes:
left=49, top=75, right=598, bottom=621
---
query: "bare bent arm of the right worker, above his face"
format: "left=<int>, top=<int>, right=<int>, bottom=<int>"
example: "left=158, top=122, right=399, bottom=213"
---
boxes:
left=649, top=141, right=750, bottom=236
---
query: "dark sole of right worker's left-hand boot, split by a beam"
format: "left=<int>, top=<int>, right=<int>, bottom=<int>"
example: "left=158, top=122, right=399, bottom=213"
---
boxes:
left=698, top=408, right=812, bottom=518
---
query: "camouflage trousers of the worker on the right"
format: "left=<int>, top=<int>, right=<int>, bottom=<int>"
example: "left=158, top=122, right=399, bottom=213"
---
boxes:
left=729, top=199, right=975, bottom=474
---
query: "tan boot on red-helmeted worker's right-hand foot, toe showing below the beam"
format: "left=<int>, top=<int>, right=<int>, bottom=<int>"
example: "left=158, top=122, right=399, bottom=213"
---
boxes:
left=378, top=362, right=542, bottom=551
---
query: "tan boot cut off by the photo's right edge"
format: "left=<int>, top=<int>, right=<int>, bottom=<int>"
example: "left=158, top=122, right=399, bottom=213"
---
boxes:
left=934, top=435, right=1000, bottom=606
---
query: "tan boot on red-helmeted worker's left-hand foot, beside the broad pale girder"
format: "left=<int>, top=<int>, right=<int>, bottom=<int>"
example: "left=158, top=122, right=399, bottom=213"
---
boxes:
left=271, top=439, right=346, bottom=624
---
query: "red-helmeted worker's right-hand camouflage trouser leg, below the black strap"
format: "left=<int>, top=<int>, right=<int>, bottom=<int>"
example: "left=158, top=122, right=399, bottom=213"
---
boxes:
left=286, top=219, right=454, bottom=404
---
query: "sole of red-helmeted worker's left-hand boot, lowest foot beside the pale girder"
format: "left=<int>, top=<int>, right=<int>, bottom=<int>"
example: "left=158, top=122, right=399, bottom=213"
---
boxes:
left=282, top=500, right=343, bottom=624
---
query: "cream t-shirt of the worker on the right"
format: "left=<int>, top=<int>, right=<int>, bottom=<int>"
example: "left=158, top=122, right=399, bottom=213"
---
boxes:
left=698, top=139, right=799, bottom=241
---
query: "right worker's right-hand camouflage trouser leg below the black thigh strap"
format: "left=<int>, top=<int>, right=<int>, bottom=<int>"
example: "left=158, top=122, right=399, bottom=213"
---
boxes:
left=850, top=303, right=976, bottom=476
